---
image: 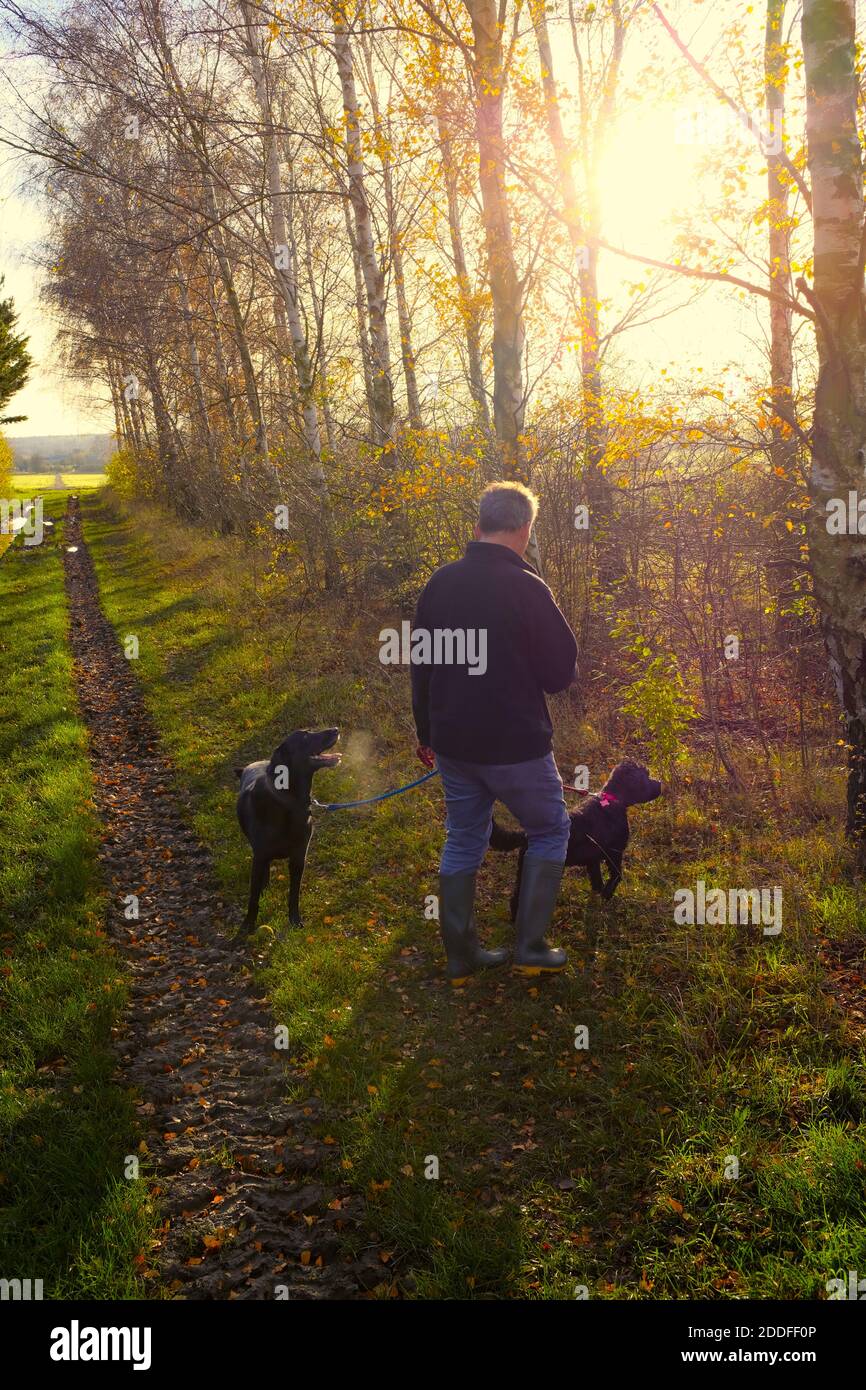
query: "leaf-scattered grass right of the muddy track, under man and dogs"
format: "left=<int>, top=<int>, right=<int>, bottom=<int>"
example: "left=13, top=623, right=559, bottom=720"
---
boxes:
left=72, top=495, right=866, bottom=1300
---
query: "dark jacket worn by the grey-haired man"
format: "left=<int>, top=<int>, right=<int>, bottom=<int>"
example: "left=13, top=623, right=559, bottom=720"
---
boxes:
left=411, top=541, right=577, bottom=763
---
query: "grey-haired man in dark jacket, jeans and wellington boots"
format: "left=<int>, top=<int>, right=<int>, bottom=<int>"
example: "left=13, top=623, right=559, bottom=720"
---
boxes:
left=411, top=482, right=577, bottom=986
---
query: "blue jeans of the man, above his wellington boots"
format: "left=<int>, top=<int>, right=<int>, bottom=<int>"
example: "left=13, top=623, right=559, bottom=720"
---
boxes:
left=436, top=753, right=571, bottom=873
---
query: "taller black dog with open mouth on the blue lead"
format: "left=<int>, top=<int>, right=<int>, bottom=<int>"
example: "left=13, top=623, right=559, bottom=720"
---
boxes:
left=235, top=728, right=341, bottom=941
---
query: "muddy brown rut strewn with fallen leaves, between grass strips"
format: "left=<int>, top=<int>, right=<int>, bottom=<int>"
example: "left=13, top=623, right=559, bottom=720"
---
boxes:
left=64, top=498, right=396, bottom=1298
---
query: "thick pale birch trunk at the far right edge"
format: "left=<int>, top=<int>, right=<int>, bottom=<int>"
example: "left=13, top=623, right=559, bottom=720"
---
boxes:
left=799, top=0, right=866, bottom=834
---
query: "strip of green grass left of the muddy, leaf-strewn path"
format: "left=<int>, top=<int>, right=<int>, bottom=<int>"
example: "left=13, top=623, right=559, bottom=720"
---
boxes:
left=0, top=495, right=153, bottom=1298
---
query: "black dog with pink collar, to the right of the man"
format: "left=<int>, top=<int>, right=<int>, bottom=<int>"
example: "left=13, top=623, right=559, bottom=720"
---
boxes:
left=491, top=758, right=662, bottom=922
